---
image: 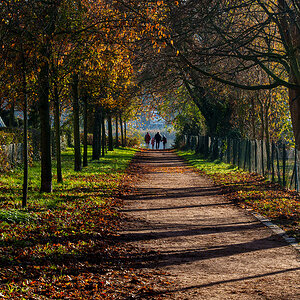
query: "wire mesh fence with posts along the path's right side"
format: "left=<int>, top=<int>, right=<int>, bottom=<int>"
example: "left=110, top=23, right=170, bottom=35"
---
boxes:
left=180, top=136, right=300, bottom=193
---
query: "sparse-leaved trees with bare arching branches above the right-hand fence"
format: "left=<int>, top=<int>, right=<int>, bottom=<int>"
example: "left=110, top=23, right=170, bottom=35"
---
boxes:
left=134, top=0, right=300, bottom=148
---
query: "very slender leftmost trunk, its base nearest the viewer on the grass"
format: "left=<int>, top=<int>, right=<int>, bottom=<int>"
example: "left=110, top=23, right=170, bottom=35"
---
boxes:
left=22, top=53, right=28, bottom=208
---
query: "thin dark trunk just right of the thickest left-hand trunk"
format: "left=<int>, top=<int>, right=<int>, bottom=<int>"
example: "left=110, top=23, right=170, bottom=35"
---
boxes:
left=54, top=80, right=63, bottom=183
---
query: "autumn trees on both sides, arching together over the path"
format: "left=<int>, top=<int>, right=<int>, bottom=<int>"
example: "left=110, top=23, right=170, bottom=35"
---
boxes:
left=0, top=0, right=300, bottom=203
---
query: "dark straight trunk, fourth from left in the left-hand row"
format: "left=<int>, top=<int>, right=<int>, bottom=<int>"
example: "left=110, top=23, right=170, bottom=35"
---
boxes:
left=72, top=73, right=81, bottom=171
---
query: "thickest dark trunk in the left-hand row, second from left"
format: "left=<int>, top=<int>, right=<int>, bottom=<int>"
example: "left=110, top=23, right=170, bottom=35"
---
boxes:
left=38, top=45, right=52, bottom=193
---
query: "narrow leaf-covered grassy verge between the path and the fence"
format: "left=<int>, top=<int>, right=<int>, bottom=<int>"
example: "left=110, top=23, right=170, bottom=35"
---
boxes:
left=178, top=151, right=300, bottom=242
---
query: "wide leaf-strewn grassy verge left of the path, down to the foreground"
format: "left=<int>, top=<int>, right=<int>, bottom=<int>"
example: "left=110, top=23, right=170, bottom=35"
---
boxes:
left=0, top=149, right=164, bottom=299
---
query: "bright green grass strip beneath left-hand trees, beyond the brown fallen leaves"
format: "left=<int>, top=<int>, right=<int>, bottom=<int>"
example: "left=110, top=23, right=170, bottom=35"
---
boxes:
left=0, top=147, right=136, bottom=212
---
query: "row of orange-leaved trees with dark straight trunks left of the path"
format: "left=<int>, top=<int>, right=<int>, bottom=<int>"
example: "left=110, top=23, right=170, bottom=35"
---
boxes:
left=0, top=0, right=166, bottom=206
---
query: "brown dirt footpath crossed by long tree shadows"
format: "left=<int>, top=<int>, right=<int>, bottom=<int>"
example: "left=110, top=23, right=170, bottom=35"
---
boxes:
left=121, top=151, right=300, bottom=300
